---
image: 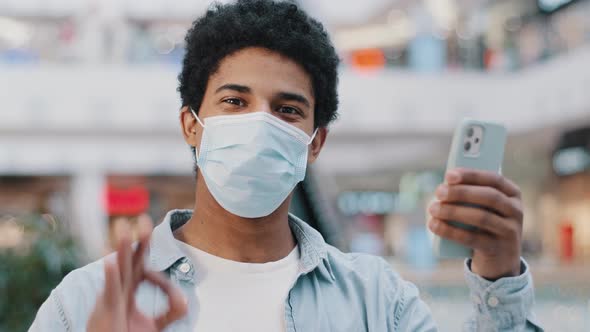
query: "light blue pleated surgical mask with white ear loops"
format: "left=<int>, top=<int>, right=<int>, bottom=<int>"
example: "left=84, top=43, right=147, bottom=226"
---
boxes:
left=191, top=109, right=317, bottom=218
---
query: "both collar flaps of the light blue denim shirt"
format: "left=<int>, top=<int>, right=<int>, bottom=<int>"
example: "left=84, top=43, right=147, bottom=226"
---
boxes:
left=148, top=210, right=335, bottom=280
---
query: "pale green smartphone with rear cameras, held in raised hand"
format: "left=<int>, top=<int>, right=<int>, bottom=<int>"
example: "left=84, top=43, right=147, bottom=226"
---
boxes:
left=433, top=119, right=506, bottom=258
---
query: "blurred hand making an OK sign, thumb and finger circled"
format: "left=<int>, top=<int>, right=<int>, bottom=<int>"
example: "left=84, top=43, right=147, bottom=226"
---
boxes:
left=87, top=218, right=187, bottom=332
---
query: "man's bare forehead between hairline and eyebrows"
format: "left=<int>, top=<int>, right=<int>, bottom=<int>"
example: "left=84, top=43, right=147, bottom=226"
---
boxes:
left=208, top=47, right=313, bottom=99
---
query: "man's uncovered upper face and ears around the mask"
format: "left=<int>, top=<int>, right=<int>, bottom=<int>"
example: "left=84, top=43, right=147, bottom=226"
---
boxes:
left=181, top=47, right=327, bottom=163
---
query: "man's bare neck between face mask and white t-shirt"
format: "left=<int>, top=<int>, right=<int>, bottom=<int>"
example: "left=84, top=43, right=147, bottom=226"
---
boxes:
left=175, top=172, right=295, bottom=263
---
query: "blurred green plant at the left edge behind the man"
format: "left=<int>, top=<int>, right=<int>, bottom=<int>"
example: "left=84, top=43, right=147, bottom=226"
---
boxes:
left=0, top=215, right=79, bottom=332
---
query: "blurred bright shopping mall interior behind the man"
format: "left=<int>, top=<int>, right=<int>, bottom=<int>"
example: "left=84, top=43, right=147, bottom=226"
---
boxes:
left=0, top=0, right=590, bottom=331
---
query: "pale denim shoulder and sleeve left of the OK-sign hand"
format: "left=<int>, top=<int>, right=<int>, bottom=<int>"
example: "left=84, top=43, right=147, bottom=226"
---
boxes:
left=32, top=255, right=112, bottom=331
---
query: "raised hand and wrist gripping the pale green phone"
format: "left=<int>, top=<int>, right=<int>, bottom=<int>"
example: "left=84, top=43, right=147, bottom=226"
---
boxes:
left=428, top=169, right=523, bottom=280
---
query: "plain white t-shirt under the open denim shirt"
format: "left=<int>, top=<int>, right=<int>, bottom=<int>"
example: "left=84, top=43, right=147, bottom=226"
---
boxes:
left=176, top=241, right=299, bottom=332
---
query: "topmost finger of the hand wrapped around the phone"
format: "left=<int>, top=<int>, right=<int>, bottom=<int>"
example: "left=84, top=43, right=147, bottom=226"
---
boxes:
left=445, top=168, right=520, bottom=197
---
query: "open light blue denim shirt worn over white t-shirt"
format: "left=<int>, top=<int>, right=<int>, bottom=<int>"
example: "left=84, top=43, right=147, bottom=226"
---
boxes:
left=29, top=210, right=542, bottom=332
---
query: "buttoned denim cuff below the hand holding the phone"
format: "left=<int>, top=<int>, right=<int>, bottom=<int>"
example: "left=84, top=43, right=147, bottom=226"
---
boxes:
left=463, top=259, right=543, bottom=332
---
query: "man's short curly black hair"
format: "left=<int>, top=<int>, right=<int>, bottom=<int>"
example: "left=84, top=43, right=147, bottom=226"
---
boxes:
left=178, top=0, right=340, bottom=127
